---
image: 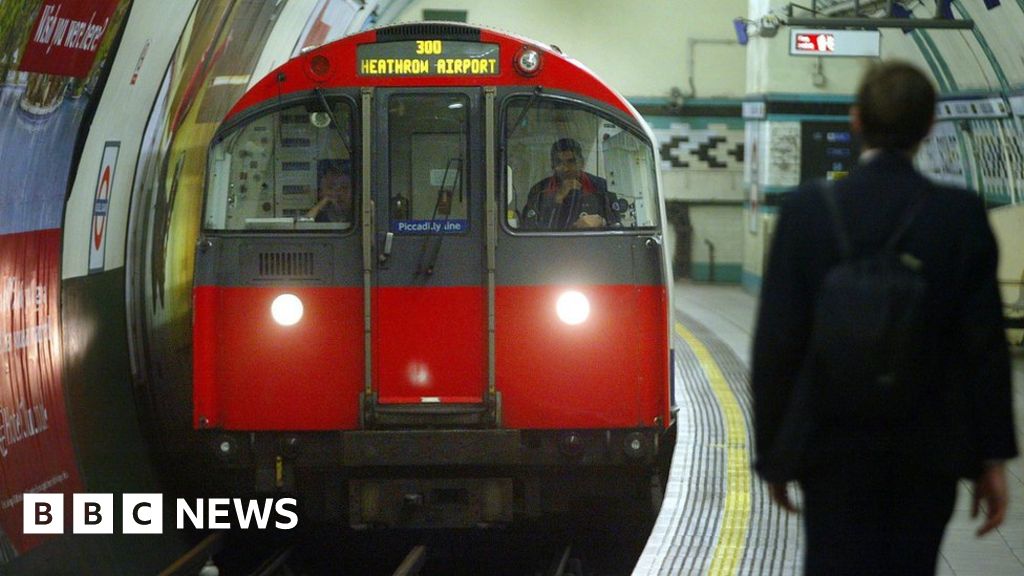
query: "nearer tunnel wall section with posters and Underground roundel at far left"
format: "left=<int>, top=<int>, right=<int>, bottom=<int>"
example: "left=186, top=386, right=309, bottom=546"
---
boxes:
left=0, top=0, right=218, bottom=574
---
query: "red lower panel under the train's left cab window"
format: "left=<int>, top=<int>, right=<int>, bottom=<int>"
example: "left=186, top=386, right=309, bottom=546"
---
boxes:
left=194, top=286, right=364, bottom=430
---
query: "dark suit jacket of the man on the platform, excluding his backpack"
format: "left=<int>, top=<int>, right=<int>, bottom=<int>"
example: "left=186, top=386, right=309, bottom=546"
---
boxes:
left=752, top=152, right=1017, bottom=481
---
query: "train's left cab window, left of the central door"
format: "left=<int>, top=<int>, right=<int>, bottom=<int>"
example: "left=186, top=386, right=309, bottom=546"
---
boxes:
left=204, top=100, right=357, bottom=231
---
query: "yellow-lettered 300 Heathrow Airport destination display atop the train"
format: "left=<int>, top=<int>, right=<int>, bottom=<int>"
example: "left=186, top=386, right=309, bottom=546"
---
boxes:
left=355, top=40, right=500, bottom=76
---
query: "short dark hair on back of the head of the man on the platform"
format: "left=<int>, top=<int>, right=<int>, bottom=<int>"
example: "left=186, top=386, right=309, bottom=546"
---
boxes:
left=857, top=60, right=936, bottom=151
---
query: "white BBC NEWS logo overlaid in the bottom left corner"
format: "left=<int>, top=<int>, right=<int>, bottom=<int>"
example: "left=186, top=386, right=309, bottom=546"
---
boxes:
left=23, top=494, right=299, bottom=534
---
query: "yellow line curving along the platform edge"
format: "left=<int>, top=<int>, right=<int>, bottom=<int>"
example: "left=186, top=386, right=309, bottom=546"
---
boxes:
left=676, top=323, right=751, bottom=576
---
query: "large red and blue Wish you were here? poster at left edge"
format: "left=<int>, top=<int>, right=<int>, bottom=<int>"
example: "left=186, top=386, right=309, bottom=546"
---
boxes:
left=0, top=0, right=130, bottom=564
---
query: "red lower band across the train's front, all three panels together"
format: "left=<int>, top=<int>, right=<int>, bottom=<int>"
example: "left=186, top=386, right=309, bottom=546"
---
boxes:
left=195, top=286, right=669, bottom=430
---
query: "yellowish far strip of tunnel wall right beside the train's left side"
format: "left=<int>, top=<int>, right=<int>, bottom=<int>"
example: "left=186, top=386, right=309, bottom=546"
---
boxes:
left=128, top=0, right=365, bottom=489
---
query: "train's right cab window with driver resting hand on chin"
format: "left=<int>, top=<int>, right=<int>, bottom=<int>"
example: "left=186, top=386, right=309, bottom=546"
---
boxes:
left=505, top=97, right=658, bottom=232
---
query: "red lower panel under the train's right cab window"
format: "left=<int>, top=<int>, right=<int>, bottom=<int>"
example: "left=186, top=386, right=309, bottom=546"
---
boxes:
left=496, top=286, right=669, bottom=428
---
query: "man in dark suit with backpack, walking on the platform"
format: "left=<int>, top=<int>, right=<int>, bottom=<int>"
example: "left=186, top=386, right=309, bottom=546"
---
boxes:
left=752, top=63, right=1017, bottom=575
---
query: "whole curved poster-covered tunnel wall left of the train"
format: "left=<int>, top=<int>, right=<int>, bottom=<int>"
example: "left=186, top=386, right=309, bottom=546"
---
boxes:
left=0, top=0, right=365, bottom=574
